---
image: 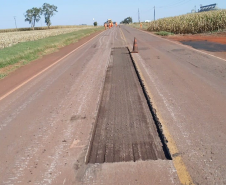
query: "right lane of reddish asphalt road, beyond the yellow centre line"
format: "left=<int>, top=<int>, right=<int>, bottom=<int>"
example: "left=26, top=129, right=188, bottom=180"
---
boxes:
left=122, top=24, right=226, bottom=184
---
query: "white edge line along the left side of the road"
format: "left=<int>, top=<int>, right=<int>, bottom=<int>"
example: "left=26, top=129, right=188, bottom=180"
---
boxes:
left=0, top=31, right=103, bottom=101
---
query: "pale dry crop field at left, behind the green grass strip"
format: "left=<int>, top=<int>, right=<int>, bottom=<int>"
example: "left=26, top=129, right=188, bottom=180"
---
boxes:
left=0, top=26, right=93, bottom=49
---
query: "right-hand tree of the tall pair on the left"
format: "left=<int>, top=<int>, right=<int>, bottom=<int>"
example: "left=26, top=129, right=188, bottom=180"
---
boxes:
left=42, top=3, right=58, bottom=28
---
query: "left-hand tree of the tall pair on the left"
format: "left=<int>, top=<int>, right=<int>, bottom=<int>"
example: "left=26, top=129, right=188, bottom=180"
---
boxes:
left=24, top=7, right=41, bottom=30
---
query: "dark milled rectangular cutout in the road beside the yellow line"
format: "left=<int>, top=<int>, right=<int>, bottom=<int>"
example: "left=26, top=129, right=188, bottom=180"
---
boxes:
left=86, top=48, right=171, bottom=163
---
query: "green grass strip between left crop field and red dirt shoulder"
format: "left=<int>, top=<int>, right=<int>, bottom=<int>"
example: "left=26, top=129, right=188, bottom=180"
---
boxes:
left=0, top=27, right=103, bottom=79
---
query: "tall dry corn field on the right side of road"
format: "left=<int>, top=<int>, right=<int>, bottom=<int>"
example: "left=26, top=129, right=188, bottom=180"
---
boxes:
left=148, top=10, right=226, bottom=34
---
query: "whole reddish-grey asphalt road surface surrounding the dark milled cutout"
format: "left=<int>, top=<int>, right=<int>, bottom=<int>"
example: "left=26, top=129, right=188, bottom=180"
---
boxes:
left=0, top=26, right=226, bottom=185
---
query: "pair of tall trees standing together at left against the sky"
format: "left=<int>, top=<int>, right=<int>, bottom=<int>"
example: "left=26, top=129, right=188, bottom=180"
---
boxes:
left=24, top=3, right=58, bottom=30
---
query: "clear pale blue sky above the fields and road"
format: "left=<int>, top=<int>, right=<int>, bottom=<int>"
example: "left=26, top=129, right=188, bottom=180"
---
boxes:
left=0, top=0, right=226, bottom=29
